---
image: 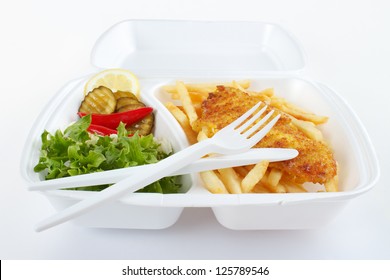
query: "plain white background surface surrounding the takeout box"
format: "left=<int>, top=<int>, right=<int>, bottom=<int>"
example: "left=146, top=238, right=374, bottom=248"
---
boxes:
left=0, top=0, right=390, bottom=259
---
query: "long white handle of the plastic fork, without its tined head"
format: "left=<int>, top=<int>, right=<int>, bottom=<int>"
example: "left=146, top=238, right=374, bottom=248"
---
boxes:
left=35, top=139, right=214, bottom=232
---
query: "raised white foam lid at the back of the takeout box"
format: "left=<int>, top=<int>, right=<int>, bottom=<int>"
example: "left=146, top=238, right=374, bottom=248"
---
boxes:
left=91, top=20, right=305, bottom=77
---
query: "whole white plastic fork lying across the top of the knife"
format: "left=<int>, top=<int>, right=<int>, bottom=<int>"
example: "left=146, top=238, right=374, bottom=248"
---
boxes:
left=35, top=102, right=280, bottom=232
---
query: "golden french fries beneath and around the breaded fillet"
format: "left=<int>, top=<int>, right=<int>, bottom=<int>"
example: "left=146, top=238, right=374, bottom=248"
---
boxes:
left=163, top=80, right=338, bottom=194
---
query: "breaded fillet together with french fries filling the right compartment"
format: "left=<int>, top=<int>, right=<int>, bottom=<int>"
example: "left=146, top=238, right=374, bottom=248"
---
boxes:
left=164, top=81, right=338, bottom=194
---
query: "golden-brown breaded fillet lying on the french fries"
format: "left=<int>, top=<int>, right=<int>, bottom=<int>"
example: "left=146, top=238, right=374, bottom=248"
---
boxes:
left=194, top=86, right=337, bottom=184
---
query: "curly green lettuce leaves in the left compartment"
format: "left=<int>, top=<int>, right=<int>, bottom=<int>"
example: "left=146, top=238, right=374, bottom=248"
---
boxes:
left=34, top=115, right=181, bottom=193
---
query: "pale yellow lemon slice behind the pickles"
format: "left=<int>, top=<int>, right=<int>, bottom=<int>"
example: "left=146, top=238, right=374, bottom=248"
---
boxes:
left=84, top=68, right=139, bottom=97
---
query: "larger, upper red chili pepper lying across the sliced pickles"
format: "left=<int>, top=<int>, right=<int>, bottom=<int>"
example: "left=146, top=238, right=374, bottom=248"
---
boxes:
left=77, top=107, right=153, bottom=129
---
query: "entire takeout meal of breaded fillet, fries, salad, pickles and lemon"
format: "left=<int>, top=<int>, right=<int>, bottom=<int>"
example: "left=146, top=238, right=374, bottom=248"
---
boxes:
left=34, top=69, right=338, bottom=194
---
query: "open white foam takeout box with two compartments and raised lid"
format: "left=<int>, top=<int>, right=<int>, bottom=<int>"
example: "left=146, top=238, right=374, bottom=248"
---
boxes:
left=21, top=20, right=379, bottom=230
